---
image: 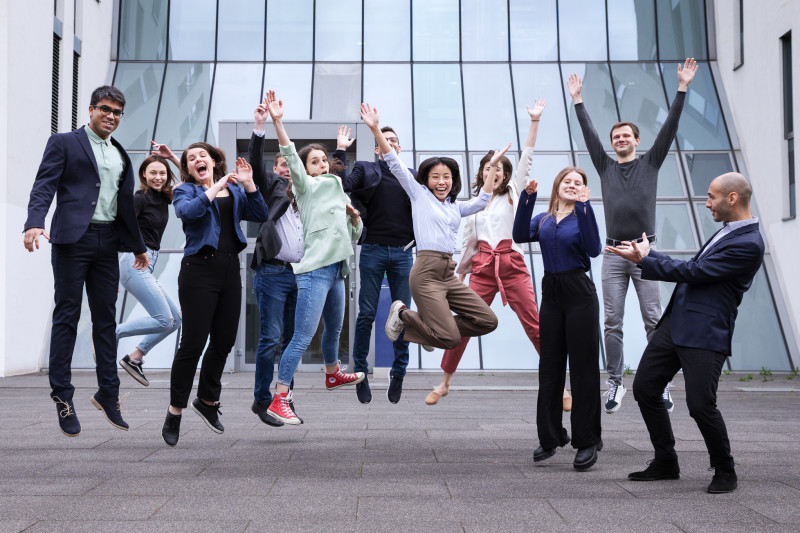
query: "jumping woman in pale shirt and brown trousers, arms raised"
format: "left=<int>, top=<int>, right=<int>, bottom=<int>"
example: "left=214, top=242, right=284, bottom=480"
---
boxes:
left=361, top=104, right=500, bottom=350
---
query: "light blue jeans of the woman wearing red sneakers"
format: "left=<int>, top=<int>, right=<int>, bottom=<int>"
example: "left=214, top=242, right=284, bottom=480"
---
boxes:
left=278, top=262, right=344, bottom=386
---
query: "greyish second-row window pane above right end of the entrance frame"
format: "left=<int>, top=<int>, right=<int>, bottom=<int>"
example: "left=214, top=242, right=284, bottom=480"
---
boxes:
left=311, top=63, right=361, bottom=121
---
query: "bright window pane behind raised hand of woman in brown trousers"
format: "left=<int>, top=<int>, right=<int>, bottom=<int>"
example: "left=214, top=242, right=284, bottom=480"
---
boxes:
left=364, top=64, right=414, bottom=153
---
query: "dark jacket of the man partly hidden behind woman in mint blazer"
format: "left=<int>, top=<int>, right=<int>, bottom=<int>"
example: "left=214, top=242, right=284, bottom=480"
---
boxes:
left=247, top=133, right=291, bottom=269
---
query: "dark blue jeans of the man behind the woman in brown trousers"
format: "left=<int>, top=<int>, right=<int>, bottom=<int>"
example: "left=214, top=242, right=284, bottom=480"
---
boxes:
left=353, top=244, right=414, bottom=377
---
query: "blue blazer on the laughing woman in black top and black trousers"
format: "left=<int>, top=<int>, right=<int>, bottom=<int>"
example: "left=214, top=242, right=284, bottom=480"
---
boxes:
left=172, top=183, right=267, bottom=256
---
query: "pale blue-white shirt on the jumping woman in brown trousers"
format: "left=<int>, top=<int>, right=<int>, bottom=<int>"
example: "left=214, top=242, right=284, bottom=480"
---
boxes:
left=383, top=151, right=490, bottom=254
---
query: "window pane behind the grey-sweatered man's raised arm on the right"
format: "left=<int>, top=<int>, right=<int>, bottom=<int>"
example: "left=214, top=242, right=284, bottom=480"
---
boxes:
left=661, top=61, right=730, bottom=150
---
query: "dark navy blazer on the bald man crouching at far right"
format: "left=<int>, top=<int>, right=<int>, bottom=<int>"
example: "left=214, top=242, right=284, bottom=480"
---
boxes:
left=640, top=223, right=764, bottom=356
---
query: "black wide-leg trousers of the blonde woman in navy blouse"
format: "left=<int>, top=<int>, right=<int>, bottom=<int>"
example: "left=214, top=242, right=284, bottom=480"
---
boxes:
left=536, top=270, right=600, bottom=449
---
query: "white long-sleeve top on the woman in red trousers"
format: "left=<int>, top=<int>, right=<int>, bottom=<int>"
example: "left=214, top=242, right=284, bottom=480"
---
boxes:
left=456, top=146, right=533, bottom=274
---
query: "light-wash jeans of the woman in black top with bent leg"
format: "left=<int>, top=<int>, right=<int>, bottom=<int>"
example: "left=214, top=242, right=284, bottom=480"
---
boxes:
left=117, top=248, right=181, bottom=355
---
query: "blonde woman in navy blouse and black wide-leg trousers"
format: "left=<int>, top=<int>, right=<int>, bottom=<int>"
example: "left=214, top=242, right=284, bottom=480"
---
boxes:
left=513, top=167, right=603, bottom=470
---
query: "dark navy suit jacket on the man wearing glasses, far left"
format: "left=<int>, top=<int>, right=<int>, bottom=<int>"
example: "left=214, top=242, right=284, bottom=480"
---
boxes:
left=25, top=127, right=146, bottom=254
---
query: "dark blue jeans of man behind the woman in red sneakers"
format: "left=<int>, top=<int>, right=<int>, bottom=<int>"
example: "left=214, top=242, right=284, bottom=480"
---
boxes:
left=253, top=263, right=297, bottom=403
